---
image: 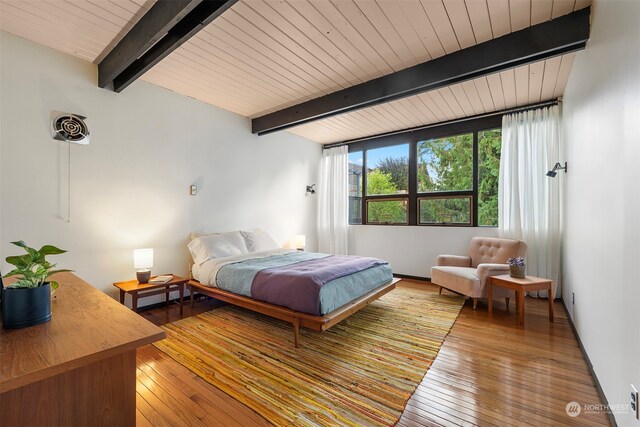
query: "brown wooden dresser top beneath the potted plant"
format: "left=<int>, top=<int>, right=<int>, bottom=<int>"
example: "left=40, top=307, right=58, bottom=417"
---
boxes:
left=0, top=273, right=165, bottom=392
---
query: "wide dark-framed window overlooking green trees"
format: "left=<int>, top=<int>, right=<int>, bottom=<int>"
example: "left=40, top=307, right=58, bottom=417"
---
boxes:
left=349, top=116, right=502, bottom=227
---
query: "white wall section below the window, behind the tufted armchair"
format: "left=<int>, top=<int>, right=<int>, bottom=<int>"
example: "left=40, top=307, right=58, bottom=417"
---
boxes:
left=349, top=225, right=498, bottom=277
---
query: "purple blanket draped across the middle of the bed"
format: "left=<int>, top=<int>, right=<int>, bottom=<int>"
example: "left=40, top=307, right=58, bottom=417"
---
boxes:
left=251, top=255, right=386, bottom=314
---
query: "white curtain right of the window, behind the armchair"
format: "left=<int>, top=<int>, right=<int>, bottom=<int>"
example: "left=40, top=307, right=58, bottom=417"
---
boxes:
left=498, top=106, right=564, bottom=298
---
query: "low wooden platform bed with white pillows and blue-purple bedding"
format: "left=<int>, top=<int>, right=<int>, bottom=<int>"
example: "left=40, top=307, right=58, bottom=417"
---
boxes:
left=188, top=230, right=398, bottom=347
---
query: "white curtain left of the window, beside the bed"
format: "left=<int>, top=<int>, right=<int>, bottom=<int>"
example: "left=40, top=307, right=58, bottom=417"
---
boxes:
left=318, top=145, right=349, bottom=255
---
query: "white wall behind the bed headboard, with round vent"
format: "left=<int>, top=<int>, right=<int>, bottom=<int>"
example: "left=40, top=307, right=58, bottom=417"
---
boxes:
left=0, top=33, right=321, bottom=305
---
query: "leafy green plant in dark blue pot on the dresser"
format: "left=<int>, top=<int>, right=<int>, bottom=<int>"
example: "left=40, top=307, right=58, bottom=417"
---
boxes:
left=2, top=240, right=72, bottom=329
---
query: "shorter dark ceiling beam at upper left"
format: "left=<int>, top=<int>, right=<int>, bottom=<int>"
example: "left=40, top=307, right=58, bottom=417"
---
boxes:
left=98, top=0, right=238, bottom=92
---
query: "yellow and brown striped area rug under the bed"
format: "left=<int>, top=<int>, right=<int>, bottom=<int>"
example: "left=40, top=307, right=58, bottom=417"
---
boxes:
left=154, top=288, right=464, bottom=426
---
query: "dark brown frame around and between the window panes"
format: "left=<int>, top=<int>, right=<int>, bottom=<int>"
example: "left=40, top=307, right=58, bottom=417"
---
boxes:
left=348, top=115, right=502, bottom=228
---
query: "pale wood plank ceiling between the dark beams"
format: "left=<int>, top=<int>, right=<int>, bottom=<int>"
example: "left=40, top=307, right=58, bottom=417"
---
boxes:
left=0, top=0, right=590, bottom=143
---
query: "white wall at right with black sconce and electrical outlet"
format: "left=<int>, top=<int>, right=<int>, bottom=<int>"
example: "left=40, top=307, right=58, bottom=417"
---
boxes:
left=563, top=0, right=640, bottom=426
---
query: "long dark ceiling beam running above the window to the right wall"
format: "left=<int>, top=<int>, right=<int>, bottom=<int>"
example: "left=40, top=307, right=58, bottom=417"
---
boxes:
left=251, top=8, right=591, bottom=135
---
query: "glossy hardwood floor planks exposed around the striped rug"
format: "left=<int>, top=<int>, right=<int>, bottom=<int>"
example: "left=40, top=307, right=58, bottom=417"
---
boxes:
left=137, top=280, right=610, bottom=427
